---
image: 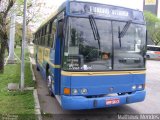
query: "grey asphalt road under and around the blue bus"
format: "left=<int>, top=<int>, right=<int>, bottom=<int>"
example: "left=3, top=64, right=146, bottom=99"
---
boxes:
left=34, top=60, right=160, bottom=120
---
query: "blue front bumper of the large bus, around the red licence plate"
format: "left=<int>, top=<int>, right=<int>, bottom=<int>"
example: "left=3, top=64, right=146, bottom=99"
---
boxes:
left=61, top=90, right=146, bottom=110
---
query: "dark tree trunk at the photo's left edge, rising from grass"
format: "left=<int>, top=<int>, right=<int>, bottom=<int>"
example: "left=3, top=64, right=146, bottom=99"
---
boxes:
left=0, top=0, right=15, bottom=73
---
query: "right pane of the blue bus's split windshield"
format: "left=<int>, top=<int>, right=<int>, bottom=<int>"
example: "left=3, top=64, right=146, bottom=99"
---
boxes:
left=113, top=22, right=146, bottom=70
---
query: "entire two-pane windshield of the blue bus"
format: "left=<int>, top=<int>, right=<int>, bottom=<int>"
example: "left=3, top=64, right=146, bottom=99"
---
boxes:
left=63, top=17, right=145, bottom=71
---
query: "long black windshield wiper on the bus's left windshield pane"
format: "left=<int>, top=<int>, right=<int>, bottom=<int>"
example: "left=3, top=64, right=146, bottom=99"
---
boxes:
left=89, top=15, right=101, bottom=50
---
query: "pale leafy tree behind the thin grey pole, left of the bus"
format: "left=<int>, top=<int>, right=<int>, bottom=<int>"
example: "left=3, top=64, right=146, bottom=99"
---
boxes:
left=15, top=0, right=45, bottom=44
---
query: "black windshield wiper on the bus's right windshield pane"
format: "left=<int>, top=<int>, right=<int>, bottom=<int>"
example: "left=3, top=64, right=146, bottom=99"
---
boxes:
left=118, top=20, right=132, bottom=47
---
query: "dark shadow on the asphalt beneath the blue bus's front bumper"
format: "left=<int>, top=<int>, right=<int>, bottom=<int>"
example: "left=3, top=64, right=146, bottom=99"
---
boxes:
left=43, top=102, right=138, bottom=120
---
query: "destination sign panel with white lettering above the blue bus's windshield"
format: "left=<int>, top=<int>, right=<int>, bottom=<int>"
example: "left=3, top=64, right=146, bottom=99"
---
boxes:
left=70, top=2, right=144, bottom=22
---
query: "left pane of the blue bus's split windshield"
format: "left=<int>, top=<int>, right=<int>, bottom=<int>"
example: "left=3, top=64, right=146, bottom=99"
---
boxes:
left=63, top=18, right=112, bottom=71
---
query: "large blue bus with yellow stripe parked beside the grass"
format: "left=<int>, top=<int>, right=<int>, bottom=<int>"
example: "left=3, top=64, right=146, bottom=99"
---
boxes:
left=34, top=1, right=146, bottom=110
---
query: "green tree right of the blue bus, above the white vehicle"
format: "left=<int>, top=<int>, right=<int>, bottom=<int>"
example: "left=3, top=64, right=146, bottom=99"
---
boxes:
left=144, top=11, right=160, bottom=45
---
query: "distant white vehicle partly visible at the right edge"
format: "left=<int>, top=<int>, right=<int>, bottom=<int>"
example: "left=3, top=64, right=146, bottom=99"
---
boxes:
left=146, top=45, right=160, bottom=60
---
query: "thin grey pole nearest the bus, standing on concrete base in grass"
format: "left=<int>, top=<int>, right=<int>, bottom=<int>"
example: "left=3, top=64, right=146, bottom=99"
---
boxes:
left=20, top=0, right=27, bottom=91
